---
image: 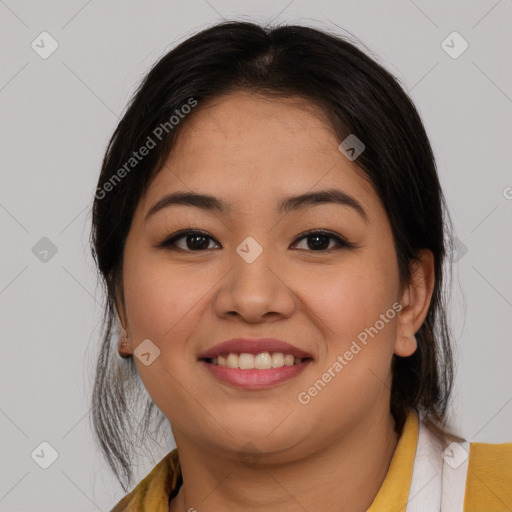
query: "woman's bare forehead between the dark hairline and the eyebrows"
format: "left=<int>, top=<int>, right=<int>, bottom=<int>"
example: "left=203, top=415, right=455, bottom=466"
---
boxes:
left=139, top=92, right=379, bottom=220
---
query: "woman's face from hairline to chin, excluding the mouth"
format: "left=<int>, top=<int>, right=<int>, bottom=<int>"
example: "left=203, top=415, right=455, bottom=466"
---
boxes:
left=116, top=92, right=424, bottom=458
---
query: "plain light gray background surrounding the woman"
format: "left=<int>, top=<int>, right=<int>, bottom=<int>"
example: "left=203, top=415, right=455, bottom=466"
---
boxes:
left=0, top=0, right=512, bottom=512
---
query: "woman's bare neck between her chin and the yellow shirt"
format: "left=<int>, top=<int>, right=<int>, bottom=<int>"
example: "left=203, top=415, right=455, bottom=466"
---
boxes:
left=169, top=409, right=398, bottom=512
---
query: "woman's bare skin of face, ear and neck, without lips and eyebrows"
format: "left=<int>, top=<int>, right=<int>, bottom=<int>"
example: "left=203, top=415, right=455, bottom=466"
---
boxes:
left=118, top=92, right=434, bottom=512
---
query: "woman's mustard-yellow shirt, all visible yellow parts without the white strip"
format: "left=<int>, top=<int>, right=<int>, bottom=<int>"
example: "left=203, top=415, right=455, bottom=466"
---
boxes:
left=110, top=411, right=512, bottom=512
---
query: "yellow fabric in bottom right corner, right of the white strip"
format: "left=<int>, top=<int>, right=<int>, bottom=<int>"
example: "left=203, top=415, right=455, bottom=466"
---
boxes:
left=464, top=443, right=512, bottom=512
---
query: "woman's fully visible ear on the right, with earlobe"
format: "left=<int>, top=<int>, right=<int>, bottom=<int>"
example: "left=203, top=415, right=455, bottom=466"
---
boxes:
left=393, top=249, right=435, bottom=357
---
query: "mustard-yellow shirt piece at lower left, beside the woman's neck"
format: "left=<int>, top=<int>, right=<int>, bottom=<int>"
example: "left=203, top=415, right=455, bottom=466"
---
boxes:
left=110, top=449, right=181, bottom=512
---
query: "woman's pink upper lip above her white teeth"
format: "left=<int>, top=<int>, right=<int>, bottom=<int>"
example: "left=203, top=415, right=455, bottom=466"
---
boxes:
left=199, top=338, right=313, bottom=359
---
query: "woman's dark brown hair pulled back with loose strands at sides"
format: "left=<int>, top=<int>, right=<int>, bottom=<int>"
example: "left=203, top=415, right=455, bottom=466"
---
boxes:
left=91, top=22, right=460, bottom=491
